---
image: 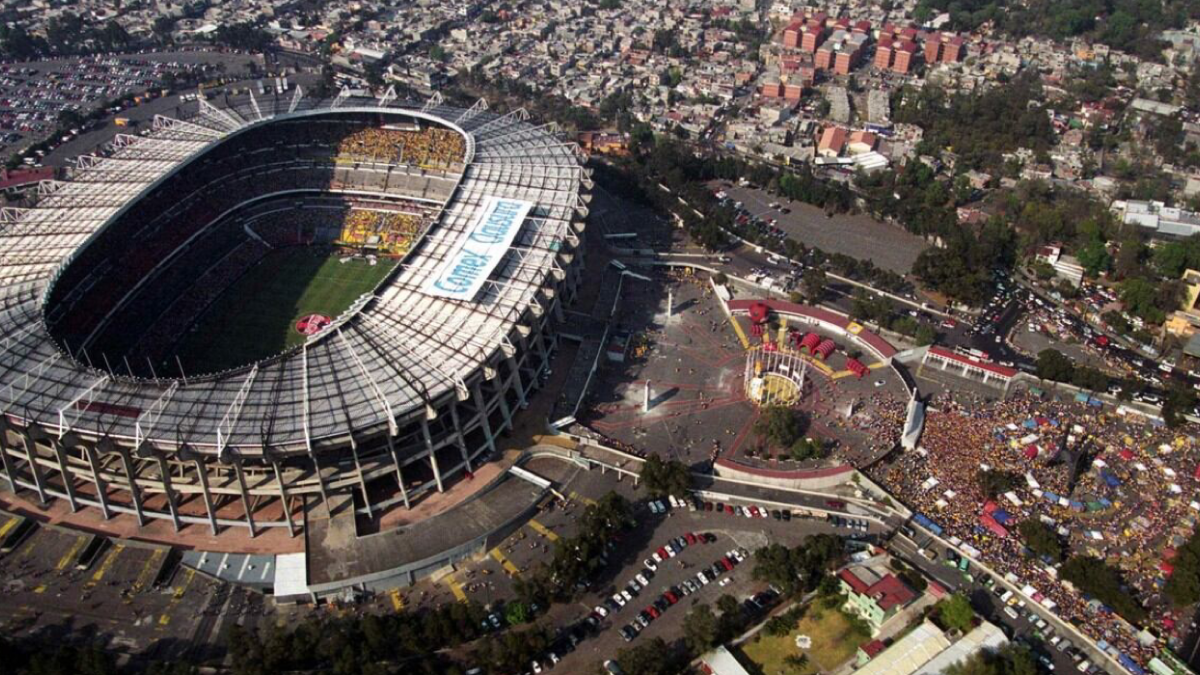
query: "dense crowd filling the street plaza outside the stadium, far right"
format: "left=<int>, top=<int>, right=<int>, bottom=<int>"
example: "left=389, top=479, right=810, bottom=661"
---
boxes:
left=868, top=394, right=1200, bottom=664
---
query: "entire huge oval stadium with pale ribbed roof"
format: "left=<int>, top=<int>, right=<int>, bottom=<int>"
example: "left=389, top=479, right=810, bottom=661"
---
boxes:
left=0, top=89, right=590, bottom=536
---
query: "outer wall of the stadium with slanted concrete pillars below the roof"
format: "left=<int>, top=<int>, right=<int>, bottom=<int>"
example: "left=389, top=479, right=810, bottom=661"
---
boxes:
left=0, top=100, right=588, bottom=540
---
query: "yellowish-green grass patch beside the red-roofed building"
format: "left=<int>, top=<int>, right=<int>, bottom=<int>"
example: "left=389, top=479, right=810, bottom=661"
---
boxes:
left=742, top=604, right=870, bottom=675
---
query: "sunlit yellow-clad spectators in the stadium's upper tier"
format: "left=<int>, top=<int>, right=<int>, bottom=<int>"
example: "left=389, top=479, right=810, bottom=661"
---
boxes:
left=337, top=126, right=467, bottom=168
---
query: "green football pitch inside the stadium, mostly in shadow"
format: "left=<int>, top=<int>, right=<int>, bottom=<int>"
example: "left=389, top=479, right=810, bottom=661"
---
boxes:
left=176, top=246, right=396, bottom=374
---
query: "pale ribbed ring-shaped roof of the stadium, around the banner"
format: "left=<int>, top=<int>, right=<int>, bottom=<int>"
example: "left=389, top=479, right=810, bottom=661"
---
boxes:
left=0, top=90, right=588, bottom=454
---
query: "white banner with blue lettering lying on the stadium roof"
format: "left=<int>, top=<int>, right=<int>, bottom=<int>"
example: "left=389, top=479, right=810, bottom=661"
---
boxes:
left=421, top=197, right=533, bottom=300
